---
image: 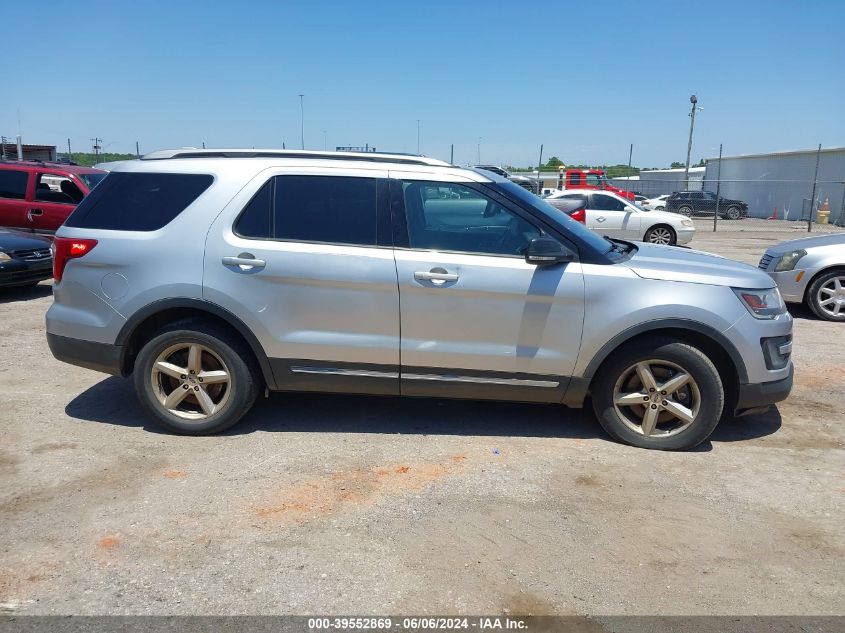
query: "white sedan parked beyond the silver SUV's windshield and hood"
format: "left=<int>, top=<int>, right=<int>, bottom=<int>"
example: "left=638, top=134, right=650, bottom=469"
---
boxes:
left=546, top=189, right=695, bottom=244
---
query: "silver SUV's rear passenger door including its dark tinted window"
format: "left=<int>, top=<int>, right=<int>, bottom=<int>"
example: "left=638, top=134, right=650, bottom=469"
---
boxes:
left=203, top=168, right=399, bottom=394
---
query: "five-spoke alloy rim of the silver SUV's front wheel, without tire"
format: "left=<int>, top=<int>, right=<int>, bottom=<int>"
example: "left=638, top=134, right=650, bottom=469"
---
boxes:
left=613, top=359, right=701, bottom=437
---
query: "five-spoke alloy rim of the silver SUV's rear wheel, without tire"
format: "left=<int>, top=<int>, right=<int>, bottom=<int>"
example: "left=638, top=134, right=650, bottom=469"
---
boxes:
left=150, top=343, right=232, bottom=422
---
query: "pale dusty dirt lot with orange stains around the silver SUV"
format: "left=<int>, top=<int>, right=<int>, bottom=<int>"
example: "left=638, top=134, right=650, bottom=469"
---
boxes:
left=0, top=220, right=845, bottom=615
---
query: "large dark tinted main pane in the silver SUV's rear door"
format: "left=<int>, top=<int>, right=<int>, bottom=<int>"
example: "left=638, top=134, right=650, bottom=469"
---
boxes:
left=273, top=176, right=377, bottom=246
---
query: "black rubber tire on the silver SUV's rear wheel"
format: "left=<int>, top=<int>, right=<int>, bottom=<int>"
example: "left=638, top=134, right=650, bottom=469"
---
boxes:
left=134, top=319, right=259, bottom=435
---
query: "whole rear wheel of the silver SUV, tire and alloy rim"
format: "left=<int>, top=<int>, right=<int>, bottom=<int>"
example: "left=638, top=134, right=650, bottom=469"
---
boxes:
left=134, top=321, right=258, bottom=435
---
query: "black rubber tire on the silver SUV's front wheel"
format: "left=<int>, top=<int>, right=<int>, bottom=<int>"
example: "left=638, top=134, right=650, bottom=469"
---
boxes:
left=593, top=337, right=725, bottom=451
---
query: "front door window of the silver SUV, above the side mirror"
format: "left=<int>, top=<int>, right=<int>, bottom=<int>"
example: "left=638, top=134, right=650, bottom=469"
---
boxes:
left=402, top=181, right=542, bottom=256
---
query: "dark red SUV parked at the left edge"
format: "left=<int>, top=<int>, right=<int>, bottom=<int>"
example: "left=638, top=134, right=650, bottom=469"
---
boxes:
left=0, top=161, right=106, bottom=235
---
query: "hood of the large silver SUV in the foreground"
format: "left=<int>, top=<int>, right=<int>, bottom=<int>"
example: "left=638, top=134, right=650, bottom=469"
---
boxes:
left=627, top=244, right=775, bottom=288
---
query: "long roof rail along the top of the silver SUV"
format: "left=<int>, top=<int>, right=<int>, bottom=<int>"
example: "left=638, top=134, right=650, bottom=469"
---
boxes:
left=141, top=147, right=452, bottom=167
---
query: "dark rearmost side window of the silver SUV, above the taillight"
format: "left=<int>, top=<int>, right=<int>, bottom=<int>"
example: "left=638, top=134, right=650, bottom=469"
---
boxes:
left=65, top=172, right=214, bottom=231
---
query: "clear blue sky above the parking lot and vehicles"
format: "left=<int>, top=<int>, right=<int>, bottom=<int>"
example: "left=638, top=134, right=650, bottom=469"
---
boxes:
left=0, top=0, right=845, bottom=166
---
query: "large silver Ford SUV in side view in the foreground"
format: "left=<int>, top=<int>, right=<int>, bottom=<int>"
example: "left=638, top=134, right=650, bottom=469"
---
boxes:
left=47, top=150, right=792, bottom=449
